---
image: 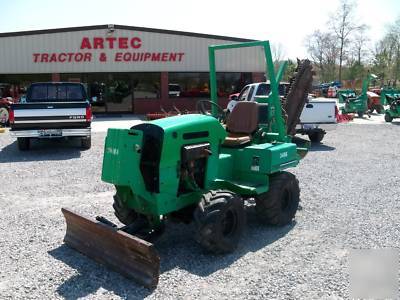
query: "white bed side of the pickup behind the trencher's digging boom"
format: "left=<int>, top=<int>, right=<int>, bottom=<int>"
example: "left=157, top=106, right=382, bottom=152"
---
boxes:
left=300, top=98, right=336, bottom=124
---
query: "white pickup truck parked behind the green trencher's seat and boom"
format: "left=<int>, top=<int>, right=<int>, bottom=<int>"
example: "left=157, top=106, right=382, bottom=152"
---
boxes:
left=226, top=81, right=336, bottom=143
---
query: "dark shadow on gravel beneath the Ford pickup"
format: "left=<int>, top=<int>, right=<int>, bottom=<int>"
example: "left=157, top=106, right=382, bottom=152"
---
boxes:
left=0, top=139, right=83, bottom=163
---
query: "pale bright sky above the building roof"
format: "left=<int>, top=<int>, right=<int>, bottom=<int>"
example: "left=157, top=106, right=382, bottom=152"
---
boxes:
left=0, top=0, right=400, bottom=59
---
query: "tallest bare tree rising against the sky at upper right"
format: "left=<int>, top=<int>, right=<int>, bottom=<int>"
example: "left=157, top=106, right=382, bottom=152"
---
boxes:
left=329, top=0, right=365, bottom=81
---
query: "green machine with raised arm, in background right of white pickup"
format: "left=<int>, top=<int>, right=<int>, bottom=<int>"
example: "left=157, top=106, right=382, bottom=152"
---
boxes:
left=338, top=74, right=377, bottom=118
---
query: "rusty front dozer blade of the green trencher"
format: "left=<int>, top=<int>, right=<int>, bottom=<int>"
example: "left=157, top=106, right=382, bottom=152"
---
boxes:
left=61, top=208, right=160, bottom=288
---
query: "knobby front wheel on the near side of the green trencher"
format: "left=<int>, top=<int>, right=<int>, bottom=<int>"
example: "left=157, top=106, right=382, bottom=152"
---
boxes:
left=194, top=190, right=246, bottom=254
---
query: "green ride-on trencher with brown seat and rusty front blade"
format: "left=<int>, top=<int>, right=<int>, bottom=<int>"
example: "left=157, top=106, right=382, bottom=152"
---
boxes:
left=62, top=41, right=308, bottom=287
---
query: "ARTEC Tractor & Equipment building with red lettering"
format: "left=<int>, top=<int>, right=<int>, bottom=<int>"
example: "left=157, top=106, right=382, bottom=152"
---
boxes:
left=0, top=25, right=265, bottom=114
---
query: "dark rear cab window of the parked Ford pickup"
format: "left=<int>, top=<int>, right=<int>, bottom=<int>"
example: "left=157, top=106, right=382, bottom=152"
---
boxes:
left=27, top=84, right=86, bottom=102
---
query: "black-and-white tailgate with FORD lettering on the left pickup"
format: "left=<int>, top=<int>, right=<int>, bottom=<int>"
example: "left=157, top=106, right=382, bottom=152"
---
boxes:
left=11, top=102, right=91, bottom=130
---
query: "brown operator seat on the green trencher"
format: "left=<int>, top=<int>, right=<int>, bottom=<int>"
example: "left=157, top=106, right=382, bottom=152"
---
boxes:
left=222, top=101, right=258, bottom=147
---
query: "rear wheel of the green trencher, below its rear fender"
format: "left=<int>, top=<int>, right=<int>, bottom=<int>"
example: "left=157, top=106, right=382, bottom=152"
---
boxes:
left=256, top=172, right=300, bottom=226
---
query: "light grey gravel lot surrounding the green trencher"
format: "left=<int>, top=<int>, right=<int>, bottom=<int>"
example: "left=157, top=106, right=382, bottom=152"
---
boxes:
left=0, top=124, right=400, bottom=299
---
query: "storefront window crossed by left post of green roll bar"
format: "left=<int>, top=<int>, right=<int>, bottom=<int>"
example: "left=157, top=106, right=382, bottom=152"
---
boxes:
left=168, top=72, right=251, bottom=98
